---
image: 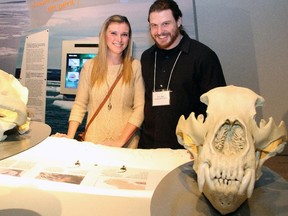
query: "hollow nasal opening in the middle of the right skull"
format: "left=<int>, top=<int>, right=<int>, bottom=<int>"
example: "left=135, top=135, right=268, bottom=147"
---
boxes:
left=214, top=120, right=246, bottom=154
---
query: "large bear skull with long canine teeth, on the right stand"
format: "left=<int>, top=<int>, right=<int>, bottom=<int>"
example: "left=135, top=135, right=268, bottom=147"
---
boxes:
left=176, top=86, right=287, bottom=214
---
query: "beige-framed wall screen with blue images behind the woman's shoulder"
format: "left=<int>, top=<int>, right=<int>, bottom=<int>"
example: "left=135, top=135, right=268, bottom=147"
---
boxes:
left=60, top=40, right=98, bottom=95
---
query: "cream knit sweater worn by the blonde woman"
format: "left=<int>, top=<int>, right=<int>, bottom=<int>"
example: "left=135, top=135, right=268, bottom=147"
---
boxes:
left=69, top=59, right=144, bottom=144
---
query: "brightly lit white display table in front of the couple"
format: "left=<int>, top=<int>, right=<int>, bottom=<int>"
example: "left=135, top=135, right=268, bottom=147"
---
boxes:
left=0, top=137, right=190, bottom=216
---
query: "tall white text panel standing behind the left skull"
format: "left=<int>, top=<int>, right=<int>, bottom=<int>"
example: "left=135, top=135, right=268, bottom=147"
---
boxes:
left=20, top=30, right=49, bottom=122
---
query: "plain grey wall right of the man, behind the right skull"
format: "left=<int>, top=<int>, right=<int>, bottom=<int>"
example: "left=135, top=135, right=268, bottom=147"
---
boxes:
left=195, top=0, right=288, bottom=126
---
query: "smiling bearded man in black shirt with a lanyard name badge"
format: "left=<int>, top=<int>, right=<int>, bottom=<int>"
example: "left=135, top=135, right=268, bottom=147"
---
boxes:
left=138, top=0, right=226, bottom=149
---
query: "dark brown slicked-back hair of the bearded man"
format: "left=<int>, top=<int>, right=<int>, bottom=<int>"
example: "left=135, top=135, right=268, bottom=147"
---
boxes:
left=148, top=0, right=184, bottom=32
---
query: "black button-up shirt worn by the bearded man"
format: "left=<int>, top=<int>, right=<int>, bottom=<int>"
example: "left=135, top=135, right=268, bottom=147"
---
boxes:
left=138, top=34, right=226, bottom=149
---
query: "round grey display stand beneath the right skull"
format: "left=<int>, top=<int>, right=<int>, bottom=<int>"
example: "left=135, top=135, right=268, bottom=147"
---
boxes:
left=151, top=162, right=288, bottom=216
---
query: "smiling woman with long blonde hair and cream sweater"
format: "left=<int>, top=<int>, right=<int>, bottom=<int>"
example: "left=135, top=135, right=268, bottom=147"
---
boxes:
left=56, top=15, right=144, bottom=148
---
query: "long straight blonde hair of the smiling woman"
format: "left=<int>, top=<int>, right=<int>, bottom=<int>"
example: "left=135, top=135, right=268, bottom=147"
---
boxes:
left=91, top=15, right=133, bottom=87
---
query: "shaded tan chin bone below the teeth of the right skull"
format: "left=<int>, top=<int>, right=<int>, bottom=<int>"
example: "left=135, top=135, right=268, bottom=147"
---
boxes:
left=203, top=186, right=247, bottom=215
